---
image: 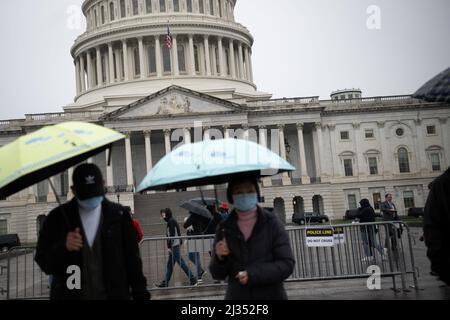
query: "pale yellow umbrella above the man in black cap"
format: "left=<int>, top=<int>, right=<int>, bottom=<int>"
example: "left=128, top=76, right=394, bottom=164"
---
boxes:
left=0, top=122, right=125, bottom=197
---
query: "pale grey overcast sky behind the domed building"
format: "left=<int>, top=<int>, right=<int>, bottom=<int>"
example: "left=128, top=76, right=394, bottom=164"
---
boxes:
left=0, top=0, right=450, bottom=119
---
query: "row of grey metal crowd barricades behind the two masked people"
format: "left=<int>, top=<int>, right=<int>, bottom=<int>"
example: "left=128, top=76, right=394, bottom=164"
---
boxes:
left=0, top=221, right=418, bottom=299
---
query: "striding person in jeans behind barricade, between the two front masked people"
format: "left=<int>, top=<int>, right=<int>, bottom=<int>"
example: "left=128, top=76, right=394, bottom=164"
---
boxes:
left=156, top=208, right=197, bottom=288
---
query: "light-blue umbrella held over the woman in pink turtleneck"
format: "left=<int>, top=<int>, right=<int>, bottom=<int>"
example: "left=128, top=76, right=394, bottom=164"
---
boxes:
left=136, top=139, right=295, bottom=192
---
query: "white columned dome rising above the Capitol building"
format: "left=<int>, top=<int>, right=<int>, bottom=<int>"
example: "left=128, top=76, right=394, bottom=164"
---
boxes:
left=65, top=0, right=271, bottom=111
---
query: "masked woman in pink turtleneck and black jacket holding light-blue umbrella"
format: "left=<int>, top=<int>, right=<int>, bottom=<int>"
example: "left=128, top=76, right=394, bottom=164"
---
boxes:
left=209, top=177, right=295, bottom=300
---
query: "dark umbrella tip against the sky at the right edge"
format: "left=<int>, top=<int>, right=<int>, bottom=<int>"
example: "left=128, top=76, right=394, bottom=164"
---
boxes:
left=413, top=68, right=450, bottom=103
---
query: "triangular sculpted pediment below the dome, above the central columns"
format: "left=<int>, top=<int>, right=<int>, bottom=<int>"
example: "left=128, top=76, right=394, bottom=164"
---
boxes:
left=104, top=86, right=242, bottom=120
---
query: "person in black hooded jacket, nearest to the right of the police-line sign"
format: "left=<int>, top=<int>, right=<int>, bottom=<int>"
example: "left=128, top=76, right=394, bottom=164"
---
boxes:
left=357, top=199, right=385, bottom=262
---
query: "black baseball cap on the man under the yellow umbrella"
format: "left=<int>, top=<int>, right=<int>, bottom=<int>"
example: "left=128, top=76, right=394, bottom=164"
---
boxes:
left=72, top=163, right=105, bottom=200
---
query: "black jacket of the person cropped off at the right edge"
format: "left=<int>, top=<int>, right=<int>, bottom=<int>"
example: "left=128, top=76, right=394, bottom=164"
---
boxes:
left=423, top=168, right=450, bottom=285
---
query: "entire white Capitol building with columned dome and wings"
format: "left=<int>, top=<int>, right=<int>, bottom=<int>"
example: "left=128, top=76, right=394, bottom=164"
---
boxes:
left=0, top=0, right=450, bottom=242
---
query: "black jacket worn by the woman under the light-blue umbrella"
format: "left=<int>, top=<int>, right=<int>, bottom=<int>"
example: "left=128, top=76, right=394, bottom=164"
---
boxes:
left=209, top=207, right=295, bottom=300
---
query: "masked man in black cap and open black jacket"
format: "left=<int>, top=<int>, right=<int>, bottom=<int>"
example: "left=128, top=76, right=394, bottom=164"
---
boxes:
left=35, top=164, right=150, bottom=300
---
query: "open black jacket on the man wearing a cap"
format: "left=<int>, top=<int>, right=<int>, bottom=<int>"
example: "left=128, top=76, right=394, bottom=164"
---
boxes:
left=35, top=199, right=150, bottom=300
